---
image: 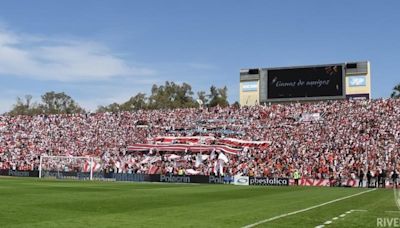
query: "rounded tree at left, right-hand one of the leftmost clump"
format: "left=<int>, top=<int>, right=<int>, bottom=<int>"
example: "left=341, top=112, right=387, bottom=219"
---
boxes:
left=39, top=91, right=84, bottom=114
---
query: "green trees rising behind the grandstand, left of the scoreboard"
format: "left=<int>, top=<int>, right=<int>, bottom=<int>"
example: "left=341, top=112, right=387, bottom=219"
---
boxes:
left=6, top=81, right=229, bottom=115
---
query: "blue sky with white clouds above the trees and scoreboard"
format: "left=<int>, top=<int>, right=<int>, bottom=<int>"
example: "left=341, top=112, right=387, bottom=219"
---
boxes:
left=0, top=0, right=400, bottom=113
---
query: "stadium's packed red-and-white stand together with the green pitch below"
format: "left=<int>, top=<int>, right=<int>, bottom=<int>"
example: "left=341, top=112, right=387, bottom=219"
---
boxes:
left=0, top=71, right=400, bottom=227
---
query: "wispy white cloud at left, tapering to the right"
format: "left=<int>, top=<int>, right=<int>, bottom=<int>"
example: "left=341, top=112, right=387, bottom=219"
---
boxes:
left=0, top=28, right=154, bottom=81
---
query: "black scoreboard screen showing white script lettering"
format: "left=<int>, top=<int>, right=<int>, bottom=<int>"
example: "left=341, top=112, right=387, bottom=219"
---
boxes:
left=267, top=65, right=344, bottom=99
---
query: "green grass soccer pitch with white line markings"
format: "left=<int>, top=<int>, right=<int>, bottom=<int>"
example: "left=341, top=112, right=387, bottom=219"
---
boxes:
left=0, top=177, right=400, bottom=228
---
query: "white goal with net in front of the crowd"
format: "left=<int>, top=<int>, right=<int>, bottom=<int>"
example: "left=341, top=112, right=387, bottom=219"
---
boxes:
left=39, top=155, right=100, bottom=180
